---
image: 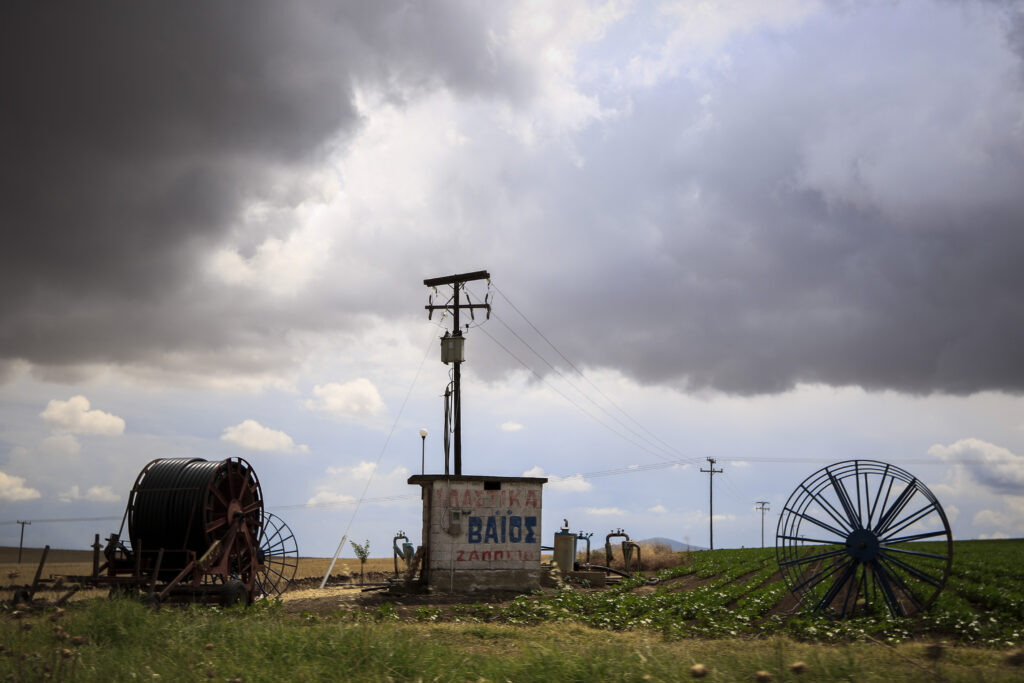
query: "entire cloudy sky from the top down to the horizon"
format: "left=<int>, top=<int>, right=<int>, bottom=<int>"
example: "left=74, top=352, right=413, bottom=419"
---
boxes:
left=0, top=0, right=1024, bottom=555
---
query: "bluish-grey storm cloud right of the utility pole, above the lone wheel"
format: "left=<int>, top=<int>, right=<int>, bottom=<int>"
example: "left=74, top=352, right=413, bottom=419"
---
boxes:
left=466, top=3, right=1024, bottom=394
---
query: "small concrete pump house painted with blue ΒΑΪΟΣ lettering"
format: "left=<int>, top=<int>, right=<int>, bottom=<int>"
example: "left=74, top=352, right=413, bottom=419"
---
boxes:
left=409, top=474, right=548, bottom=592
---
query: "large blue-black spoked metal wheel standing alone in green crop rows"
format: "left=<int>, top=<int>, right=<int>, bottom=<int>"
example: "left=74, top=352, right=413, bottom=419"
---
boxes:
left=775, top=460, right=953, bottom=617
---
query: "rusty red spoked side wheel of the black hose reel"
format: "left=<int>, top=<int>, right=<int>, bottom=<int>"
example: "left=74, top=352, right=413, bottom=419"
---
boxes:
left=195, top=458, right=263, bottom=600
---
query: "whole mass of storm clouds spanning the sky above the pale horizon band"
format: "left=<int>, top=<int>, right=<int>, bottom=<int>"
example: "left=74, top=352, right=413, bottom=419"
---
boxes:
left=0, top=2, right=1024, bottom=394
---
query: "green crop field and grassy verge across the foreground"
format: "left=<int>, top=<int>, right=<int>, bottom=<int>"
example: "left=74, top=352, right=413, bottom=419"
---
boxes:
left=0, top=540, right=1024, bottom=682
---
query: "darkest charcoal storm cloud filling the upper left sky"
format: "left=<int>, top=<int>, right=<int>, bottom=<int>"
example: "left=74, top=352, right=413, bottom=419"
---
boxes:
left=0, top=2, right=515, bottom=374
